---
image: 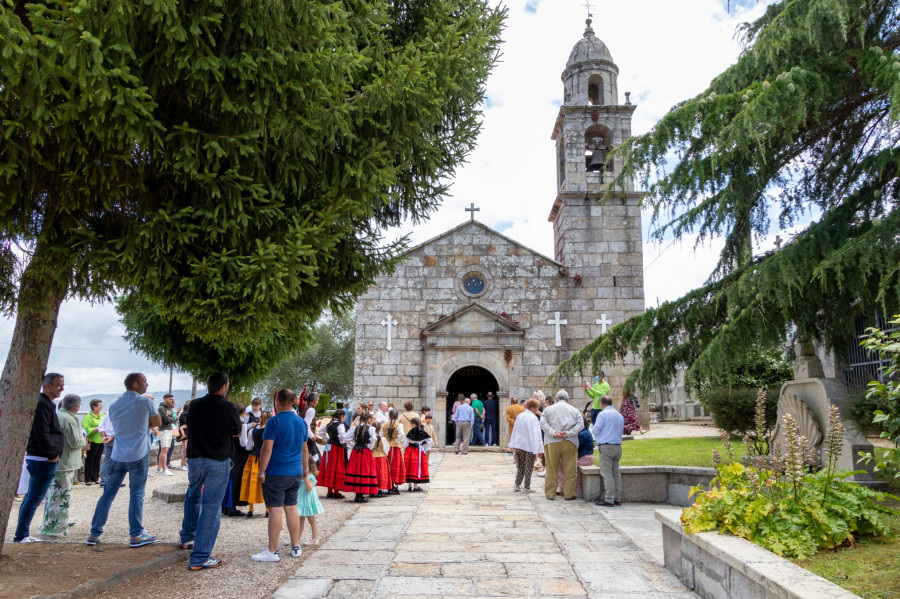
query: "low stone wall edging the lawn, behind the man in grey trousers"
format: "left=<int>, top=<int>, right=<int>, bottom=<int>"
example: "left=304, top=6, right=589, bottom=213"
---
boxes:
left=578, top=466, right=716, bottom=507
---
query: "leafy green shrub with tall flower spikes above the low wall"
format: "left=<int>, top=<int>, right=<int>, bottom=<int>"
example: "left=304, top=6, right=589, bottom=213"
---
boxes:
left=681, top=389, right=897, bottom=558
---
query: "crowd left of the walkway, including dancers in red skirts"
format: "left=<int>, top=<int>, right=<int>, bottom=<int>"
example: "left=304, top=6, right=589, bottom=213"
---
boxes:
left=13, top=372, right=434, bottom=570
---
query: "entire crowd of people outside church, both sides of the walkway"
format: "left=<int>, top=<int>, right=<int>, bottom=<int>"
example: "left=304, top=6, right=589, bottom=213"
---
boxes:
left=13, top=372, right=640, bottom=570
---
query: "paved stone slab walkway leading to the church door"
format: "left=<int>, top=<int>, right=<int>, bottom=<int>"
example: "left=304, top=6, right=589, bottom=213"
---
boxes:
left=275, top=454, right=696, bottom=599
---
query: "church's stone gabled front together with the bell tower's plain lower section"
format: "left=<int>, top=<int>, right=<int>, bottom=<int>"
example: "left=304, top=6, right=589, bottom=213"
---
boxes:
left=354, top=218, right=643, bottom=442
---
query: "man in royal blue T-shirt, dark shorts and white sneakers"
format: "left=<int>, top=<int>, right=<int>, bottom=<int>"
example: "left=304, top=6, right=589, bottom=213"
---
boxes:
left=250, top=389, right=309, bottom=562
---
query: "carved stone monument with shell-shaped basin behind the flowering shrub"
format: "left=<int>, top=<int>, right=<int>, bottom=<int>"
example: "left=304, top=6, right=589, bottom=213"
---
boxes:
left=773, top=343, right=875, bottom=483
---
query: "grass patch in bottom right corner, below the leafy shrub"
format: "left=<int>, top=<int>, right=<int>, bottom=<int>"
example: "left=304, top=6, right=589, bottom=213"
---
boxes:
left=791, top=504, right=900, bottom=599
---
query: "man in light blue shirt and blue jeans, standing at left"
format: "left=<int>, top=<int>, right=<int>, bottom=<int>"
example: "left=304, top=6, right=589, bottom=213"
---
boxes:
left=85, top=372, right=162, bottom=547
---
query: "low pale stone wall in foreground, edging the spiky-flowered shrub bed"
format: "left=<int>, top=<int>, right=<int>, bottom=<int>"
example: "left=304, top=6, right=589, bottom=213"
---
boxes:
left=656, top=509, right=859, bottom=599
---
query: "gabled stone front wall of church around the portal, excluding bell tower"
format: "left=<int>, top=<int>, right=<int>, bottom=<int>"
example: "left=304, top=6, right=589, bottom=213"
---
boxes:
left=354, top=223, right=574, bottom=405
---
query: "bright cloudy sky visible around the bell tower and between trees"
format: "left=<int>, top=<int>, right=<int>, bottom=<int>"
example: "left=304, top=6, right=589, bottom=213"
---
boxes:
left=0, top=0, right=784, bottom=397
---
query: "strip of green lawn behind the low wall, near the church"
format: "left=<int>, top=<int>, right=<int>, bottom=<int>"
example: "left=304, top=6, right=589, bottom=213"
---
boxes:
left=620, top=437, right=744, bottom=468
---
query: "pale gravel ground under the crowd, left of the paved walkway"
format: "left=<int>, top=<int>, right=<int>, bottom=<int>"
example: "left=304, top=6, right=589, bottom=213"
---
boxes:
left=6, top=462, right=360, bottom=599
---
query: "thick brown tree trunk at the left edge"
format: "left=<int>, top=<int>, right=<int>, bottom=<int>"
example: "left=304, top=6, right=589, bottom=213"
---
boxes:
left=0, top=241, right=69, bottom=552
